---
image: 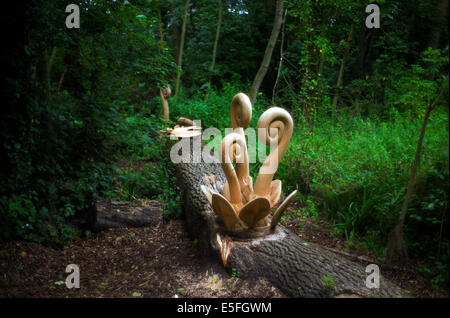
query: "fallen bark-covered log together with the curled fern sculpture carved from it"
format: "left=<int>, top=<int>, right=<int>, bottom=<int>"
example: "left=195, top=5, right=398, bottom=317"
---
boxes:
left=175, top=95, right=408, bottom=297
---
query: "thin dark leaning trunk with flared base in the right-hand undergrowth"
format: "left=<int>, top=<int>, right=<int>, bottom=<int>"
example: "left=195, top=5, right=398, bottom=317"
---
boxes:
left=385, top=80, right=448, bottom=265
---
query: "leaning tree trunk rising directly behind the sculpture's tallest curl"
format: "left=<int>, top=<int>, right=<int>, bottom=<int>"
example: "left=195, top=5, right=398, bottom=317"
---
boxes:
left=249, top=0, right=283, bottom=105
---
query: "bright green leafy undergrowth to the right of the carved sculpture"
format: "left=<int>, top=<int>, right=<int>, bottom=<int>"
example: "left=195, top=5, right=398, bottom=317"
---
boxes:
left=277, top=110, right=449, bottom=288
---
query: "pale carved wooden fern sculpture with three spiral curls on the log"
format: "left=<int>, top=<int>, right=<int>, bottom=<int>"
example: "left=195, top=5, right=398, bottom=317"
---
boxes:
left=201, top=93, right=297, bottom=232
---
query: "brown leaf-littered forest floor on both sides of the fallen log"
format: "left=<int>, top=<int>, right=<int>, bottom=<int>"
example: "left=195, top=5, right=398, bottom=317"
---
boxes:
left=0, top=200, right=448, bottom=298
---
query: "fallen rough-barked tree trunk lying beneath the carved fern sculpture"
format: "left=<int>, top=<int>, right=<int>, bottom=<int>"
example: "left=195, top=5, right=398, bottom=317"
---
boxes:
left=176, top=137, right=407, bottom=297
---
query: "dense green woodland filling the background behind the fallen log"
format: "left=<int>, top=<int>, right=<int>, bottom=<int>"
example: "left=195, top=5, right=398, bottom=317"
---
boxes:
left=0, top=0, right=449, bottom=296
